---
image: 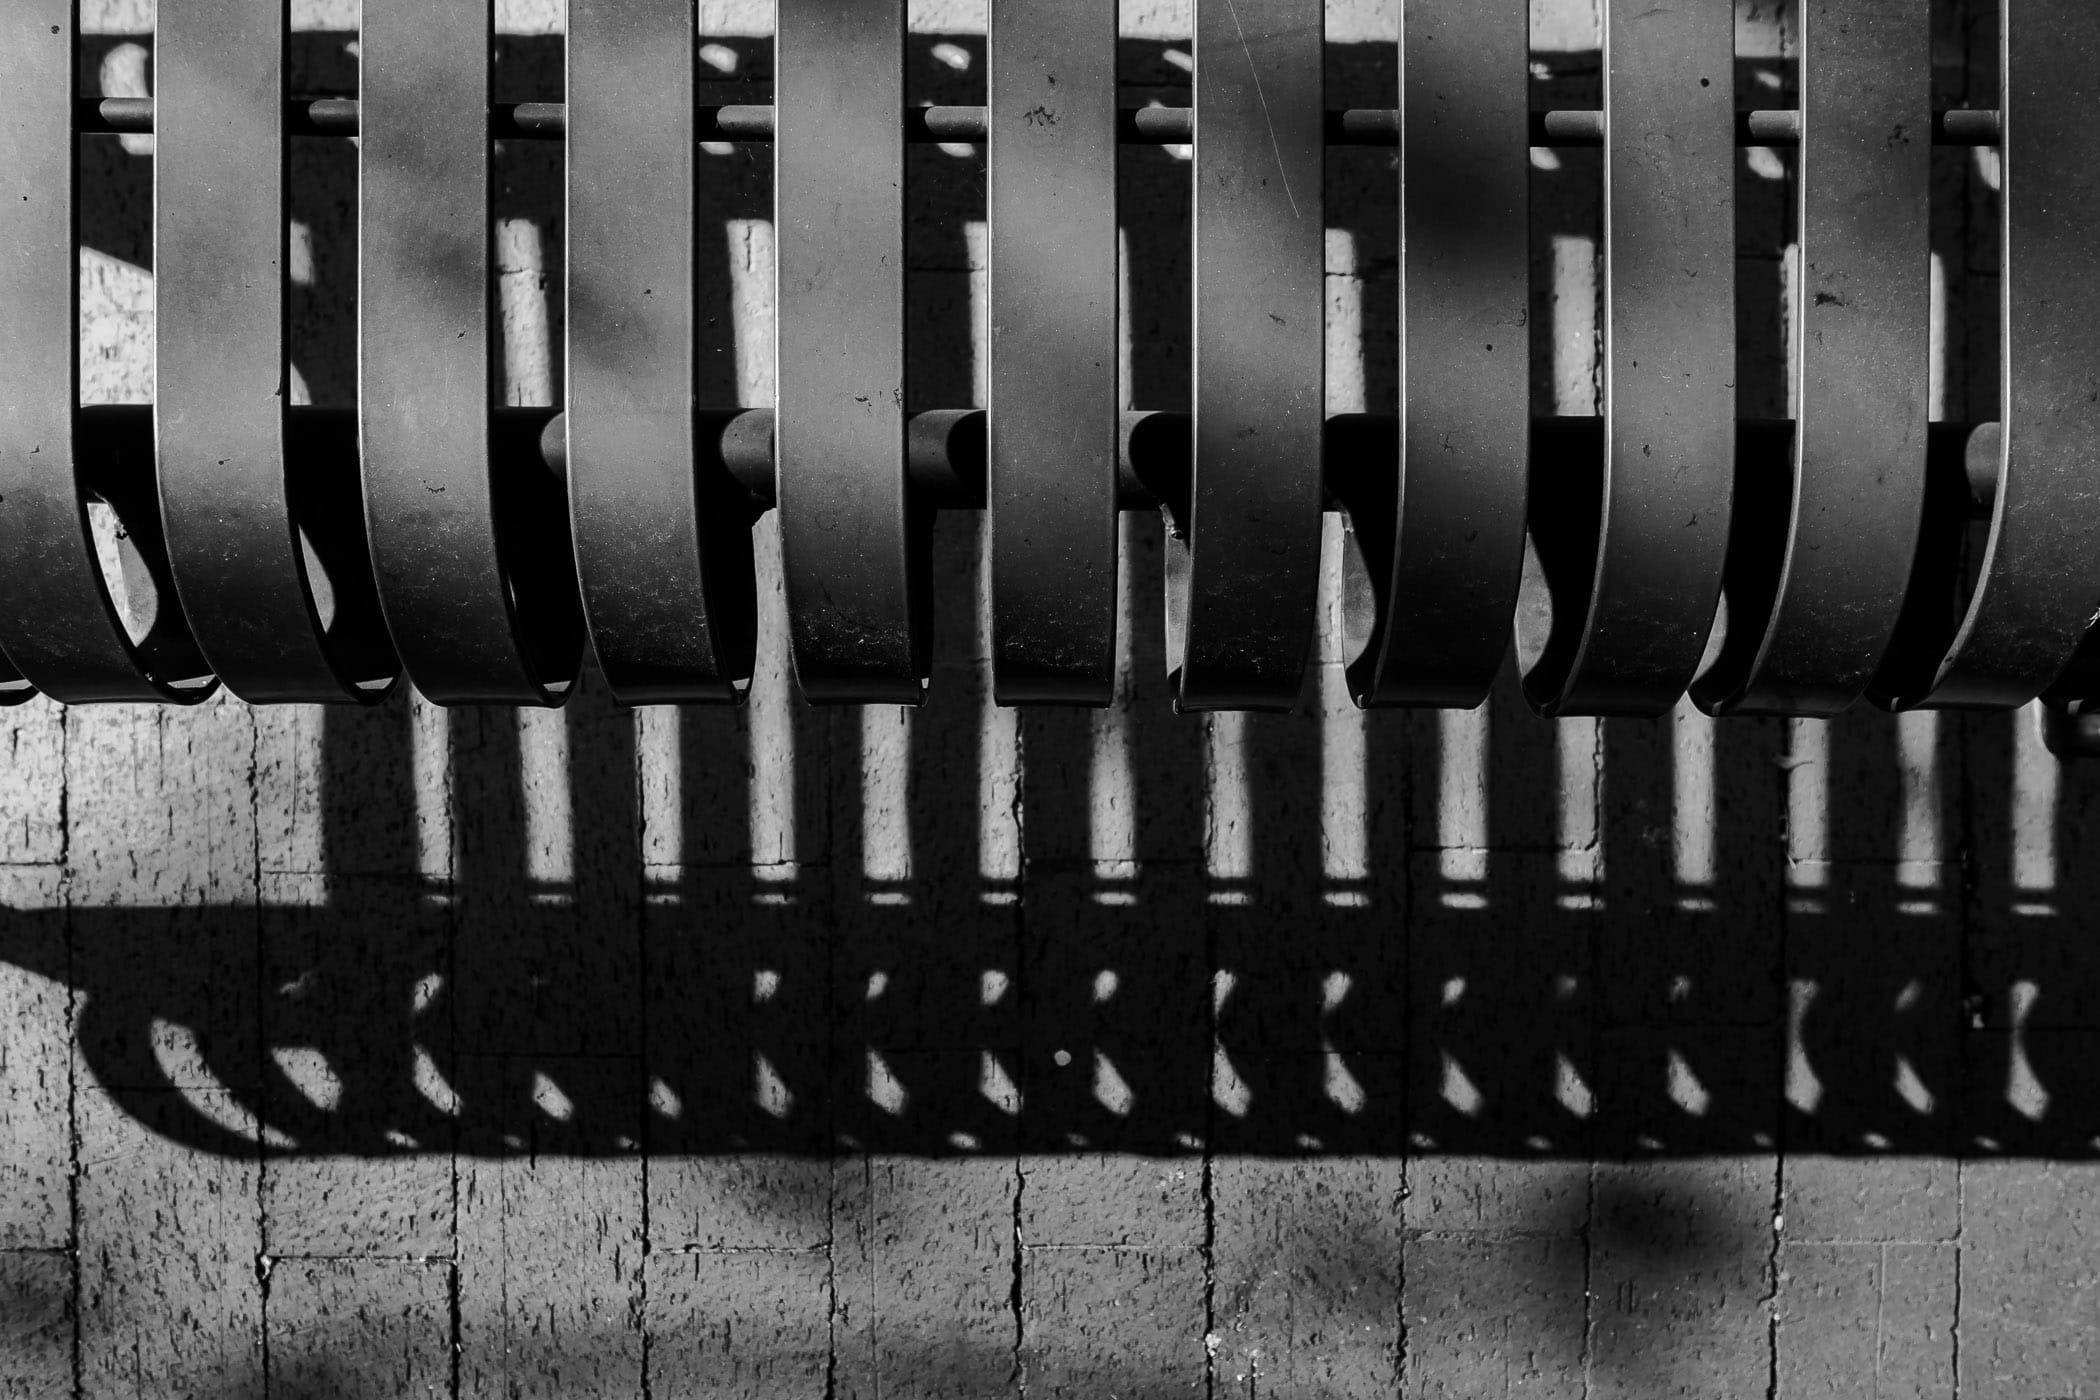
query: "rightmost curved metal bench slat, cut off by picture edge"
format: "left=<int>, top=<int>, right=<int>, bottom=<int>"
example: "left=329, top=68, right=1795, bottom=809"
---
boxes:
left=1915, top=0, right=2100, bottom=709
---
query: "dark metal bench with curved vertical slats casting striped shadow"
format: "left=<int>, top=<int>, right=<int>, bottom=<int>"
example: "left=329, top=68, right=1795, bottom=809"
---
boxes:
left=0, top=0, right=2100, bottom=749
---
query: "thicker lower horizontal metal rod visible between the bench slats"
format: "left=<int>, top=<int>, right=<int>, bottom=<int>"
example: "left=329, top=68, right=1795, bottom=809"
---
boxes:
left=80, top=403, right=1999, bottom=518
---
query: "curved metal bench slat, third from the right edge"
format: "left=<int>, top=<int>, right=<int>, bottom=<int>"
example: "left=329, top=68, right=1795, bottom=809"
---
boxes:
left=1525, top=0, right=1737, bottom=716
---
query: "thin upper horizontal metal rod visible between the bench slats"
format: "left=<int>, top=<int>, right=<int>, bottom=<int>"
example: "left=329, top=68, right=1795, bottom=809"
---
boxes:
left=80, top=97, right=1999, bottom=147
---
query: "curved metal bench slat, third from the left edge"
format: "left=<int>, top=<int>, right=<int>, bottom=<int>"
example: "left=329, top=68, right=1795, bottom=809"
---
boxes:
left=357, top=0, right=580, bottom=705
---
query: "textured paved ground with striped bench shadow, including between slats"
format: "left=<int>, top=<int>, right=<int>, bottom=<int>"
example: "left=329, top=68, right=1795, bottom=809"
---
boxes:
left=0, top=0, right=2100, bottom=1400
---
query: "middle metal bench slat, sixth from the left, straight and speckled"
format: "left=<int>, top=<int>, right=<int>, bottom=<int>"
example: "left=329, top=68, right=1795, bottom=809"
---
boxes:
left=987, top=0, right=1119, bottom=705
